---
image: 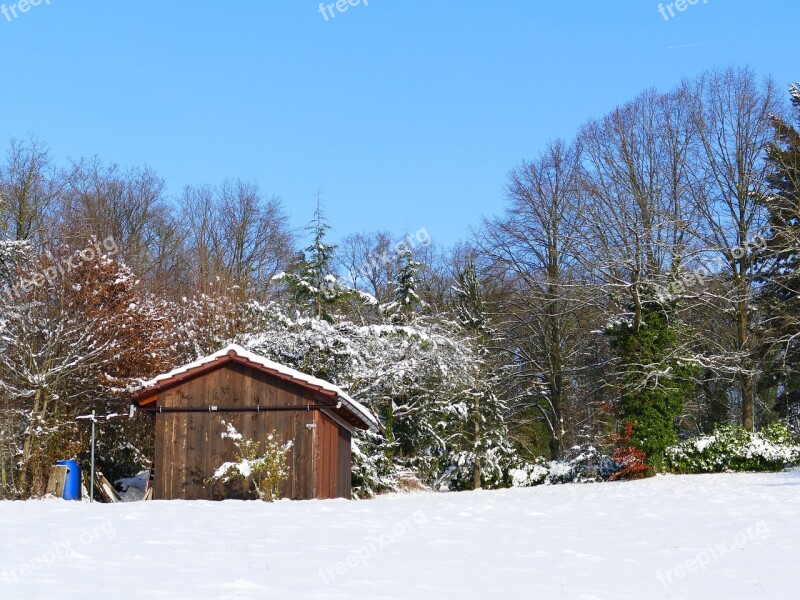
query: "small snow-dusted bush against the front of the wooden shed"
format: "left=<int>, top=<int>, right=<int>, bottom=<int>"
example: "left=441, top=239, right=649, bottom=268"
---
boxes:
left=208, top=421, right=292, bottom=502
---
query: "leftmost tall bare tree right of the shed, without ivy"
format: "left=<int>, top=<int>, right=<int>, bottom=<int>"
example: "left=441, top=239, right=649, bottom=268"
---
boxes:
left=479, top=141, right=582, bottom=459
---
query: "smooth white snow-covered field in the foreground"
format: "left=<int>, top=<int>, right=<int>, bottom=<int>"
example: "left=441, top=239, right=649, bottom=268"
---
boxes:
left=0, top=471, right=800, bottom=600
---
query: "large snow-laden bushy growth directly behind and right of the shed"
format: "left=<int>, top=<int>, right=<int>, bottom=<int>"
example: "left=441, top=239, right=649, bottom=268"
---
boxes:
left=242, top=303, right=507, bottom=497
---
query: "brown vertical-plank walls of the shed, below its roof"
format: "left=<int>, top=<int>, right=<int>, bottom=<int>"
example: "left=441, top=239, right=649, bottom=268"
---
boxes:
left=153, top=363, right=351, bottom=500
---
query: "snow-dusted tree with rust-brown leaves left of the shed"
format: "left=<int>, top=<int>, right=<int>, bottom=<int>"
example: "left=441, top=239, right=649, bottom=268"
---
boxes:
left=0, top=249, right=179, bottom=498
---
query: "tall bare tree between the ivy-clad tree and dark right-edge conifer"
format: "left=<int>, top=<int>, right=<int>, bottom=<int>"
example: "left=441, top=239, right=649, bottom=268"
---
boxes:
left=690, top=68, right=780, bottom=430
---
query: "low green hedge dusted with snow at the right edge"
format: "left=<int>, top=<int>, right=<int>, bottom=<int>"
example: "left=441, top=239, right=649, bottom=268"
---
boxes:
left=665, top=423, right=800, bottom=473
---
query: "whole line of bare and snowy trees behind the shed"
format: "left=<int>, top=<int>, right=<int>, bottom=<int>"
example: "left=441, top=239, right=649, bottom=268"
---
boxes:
left=0, top=68, right=800, bottom=497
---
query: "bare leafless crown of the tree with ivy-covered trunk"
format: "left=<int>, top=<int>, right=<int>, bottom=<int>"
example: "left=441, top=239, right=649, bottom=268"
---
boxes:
left=581, top=90, right=693, bottom=324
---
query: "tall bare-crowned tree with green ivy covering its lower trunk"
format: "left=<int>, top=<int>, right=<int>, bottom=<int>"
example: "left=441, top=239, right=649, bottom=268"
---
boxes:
left=580, top=85, right=692, bottom=461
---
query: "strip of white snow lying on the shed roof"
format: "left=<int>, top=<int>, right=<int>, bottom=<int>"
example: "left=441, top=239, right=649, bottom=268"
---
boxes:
left=134, top=344, right=381, bottom=433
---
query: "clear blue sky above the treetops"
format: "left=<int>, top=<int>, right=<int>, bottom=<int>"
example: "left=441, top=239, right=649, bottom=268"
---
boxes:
left=0, top=0, right=800, bottom=245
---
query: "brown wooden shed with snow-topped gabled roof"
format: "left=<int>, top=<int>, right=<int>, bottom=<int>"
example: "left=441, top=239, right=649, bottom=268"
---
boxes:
left=132, top=345, right=380, bottom=500
